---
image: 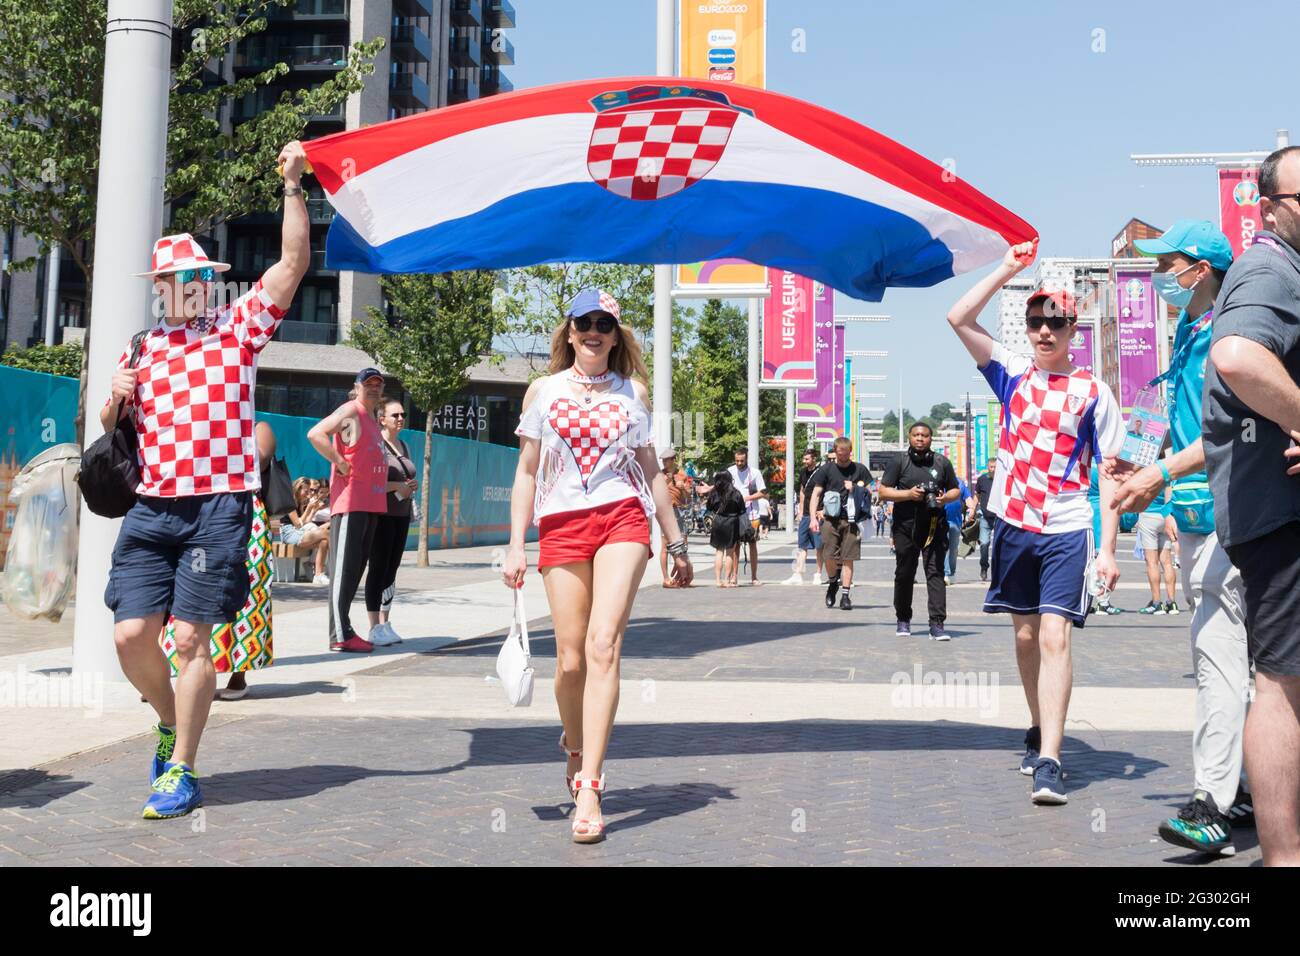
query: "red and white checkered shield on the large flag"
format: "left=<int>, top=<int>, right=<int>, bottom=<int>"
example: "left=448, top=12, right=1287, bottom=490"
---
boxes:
left=586, top=105, right=738, bottom=199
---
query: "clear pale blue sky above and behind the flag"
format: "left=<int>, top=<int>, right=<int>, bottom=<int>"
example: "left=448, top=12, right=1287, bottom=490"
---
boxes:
left=507, top=0, right=1300, bottom=414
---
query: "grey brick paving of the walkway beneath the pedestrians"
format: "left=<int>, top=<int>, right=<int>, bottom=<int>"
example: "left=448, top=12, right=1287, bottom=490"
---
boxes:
left=0, top=538, right=1260, bottom=866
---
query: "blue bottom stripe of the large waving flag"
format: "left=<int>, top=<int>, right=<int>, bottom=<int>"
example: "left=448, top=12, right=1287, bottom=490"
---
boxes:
left=325, top=179, right=953, bottom=302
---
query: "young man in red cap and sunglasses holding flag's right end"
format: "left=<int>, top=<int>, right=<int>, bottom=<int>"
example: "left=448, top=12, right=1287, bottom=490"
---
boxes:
left=948, top=242, right=1123, bottom=804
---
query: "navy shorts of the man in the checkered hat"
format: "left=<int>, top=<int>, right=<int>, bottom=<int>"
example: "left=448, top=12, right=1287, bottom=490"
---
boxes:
left=104, top=492, right=252, bottom=624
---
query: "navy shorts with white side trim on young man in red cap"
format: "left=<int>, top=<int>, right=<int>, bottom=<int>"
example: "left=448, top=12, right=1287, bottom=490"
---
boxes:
left=984, top=522, right=1092, bottom=627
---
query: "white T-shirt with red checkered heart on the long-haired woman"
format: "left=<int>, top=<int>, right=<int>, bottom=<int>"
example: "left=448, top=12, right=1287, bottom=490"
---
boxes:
left=515, top=372, right=654, bottom=524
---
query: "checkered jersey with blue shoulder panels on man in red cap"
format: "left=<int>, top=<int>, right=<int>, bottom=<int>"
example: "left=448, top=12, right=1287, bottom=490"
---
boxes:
left=980, top=343, right=1125, bottom=535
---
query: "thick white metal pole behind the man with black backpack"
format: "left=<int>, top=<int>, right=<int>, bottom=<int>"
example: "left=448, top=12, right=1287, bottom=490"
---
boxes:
left=73, top=0, right=172, bottom=680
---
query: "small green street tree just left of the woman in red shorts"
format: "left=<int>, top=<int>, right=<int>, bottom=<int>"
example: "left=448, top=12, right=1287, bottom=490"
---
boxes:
left=350, top=272, right=504, bottom=567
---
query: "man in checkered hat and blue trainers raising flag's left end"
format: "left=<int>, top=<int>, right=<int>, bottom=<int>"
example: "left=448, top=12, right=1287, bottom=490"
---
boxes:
left=100, top=140, right=311, bottom=819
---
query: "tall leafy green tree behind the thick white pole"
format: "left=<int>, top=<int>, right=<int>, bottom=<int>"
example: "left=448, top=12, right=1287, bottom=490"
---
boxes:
left=0, top=0, right=385, bottom=434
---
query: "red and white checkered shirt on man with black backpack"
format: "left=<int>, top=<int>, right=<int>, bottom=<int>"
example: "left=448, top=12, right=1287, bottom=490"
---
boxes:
left=117, top=281, right=285, bottom=498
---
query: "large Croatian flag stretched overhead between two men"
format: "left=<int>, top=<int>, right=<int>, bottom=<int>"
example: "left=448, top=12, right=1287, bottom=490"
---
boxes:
left=306, top=77, right=1036, bottom=300
